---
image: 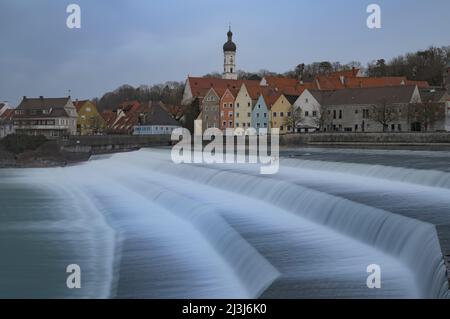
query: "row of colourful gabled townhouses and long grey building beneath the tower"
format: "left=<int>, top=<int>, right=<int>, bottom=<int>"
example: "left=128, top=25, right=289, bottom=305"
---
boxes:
left=182, top=65, right=450, bottom=134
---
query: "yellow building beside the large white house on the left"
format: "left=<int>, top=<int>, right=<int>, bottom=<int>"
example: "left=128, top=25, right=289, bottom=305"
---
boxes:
left=74, top=100, right=106, bottom=135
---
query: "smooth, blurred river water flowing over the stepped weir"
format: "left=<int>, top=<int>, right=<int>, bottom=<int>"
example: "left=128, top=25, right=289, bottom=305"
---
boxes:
left=0, top=149, right=450, bottom=298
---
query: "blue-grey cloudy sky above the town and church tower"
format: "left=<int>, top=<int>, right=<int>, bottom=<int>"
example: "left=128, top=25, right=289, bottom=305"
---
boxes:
left=0, top=0, right=450, bottom=105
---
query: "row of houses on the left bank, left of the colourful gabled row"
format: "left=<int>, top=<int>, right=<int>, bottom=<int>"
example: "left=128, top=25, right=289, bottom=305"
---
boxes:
left=0, top=96, right=180, bottom=138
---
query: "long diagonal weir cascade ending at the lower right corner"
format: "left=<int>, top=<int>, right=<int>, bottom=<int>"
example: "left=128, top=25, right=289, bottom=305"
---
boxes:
left=112, top=153, right=449, bottom=298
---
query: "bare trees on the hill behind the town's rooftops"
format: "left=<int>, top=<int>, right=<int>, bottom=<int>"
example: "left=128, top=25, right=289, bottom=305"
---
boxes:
left=94, top=46, right=450, bottom=111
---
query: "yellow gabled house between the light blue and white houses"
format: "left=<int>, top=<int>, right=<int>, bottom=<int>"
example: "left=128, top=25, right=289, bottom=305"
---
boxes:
left=270, top=94, right=298, bottom=134
